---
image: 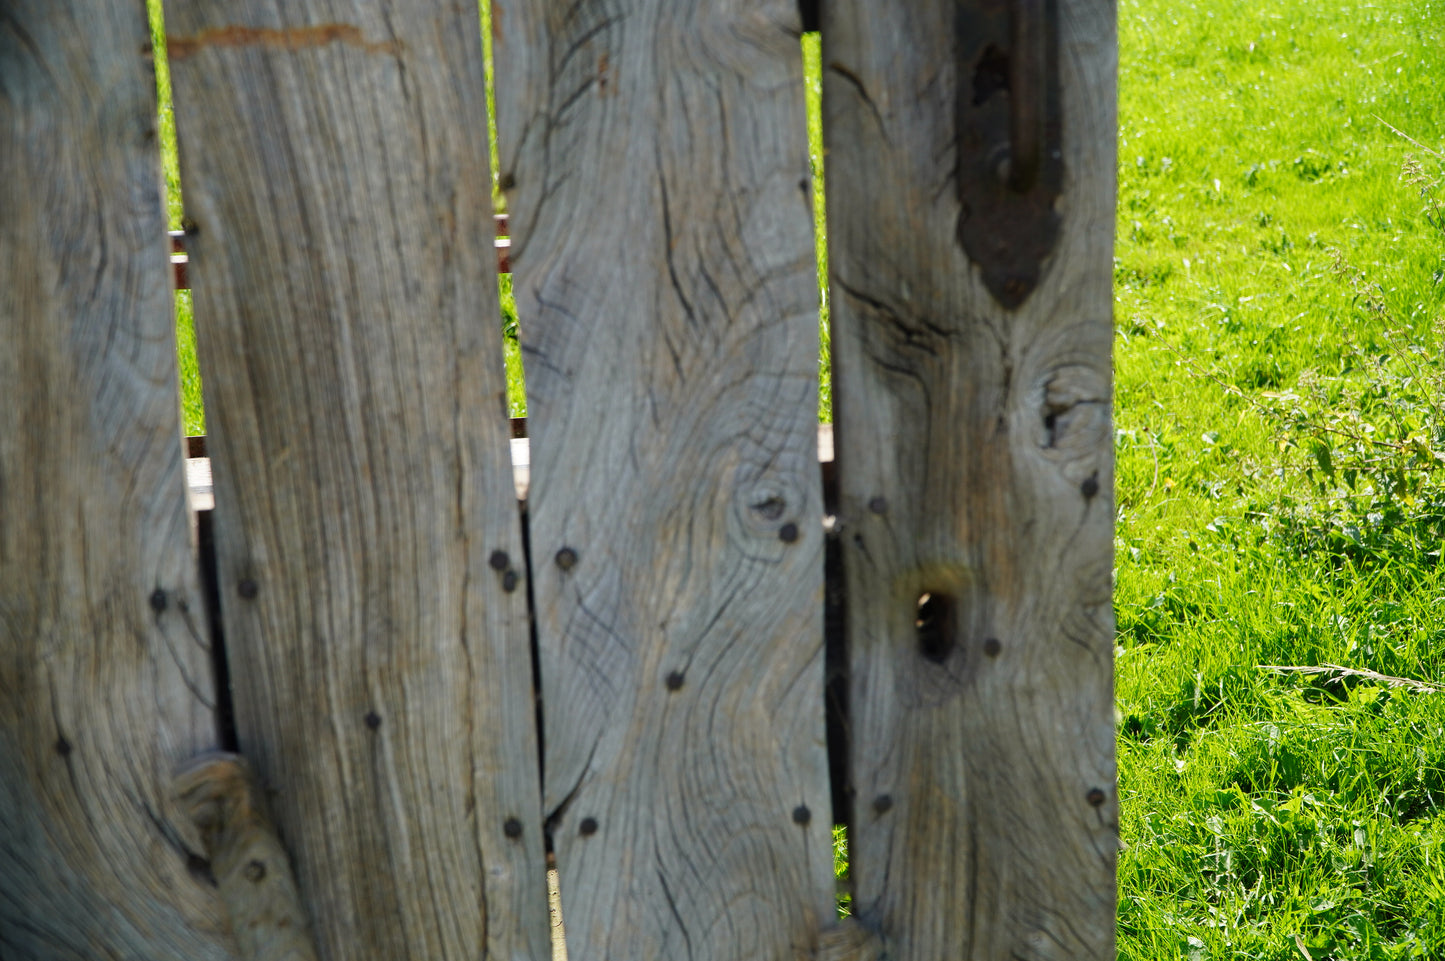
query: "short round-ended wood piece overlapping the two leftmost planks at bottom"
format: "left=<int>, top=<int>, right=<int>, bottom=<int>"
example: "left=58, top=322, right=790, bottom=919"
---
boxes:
left=172, top=751, right=316, bottom=961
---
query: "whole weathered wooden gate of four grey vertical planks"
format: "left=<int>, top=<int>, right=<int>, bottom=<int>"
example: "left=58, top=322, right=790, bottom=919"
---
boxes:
left=0, top=0, right=1117, bottom=961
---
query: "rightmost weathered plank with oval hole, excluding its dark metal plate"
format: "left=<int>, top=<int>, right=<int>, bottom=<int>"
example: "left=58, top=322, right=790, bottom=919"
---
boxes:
left=822, top=0, right=1117, bottom=961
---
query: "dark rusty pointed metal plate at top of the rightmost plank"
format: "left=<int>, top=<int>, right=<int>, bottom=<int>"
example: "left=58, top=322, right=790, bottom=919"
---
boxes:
left=954, top=0, right=1064, bottom=309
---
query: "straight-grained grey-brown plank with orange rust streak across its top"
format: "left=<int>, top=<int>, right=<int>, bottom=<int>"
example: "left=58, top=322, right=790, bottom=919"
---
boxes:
left=168, top=7, right=548, bottom=961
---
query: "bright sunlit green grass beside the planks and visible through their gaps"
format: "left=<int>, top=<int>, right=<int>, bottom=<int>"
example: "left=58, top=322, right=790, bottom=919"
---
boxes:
left=150, top=0, right=1445, bottom=961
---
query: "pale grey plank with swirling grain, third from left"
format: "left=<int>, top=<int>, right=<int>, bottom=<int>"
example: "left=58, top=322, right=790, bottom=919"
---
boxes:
left=494, top=0, right=832, bottom=961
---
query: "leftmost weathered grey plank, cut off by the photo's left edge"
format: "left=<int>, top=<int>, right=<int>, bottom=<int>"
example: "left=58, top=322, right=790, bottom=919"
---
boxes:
left=0, top=0, right=231, bottom=961
